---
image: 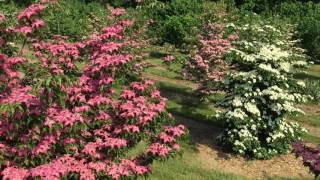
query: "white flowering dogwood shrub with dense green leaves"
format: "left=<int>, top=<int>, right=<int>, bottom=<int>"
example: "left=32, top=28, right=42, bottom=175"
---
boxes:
left=219, top=21, right=305, bottom=159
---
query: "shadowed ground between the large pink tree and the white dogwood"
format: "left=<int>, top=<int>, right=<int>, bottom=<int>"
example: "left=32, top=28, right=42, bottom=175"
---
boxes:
left=154, top=84, right=232, bottom=160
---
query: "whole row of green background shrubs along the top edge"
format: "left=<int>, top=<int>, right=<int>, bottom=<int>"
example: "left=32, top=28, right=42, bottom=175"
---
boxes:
left=0, top=0, right=320, bottom=63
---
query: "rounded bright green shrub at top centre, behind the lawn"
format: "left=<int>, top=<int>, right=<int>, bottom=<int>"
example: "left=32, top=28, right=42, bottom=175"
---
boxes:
left=142, top=0, right=203, bottom=47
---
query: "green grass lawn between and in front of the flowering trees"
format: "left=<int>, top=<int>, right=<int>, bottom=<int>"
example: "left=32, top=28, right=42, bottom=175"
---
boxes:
left=141, top=49, right=320, bottom=180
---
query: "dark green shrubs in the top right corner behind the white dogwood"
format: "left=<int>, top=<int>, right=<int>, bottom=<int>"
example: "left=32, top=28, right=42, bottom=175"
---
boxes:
left=233, top=0, right=320, bottom=63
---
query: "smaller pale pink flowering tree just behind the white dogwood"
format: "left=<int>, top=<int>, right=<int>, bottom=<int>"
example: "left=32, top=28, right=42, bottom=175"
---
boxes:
left=183, top=24, right=237, bottom=92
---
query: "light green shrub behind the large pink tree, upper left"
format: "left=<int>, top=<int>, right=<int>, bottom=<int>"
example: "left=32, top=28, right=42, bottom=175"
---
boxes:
left=44, top=0, right=107, bottom=40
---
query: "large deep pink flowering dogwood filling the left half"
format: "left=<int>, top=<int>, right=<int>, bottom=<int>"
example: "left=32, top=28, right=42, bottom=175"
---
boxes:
left=0, top=4, right=186, bottom=180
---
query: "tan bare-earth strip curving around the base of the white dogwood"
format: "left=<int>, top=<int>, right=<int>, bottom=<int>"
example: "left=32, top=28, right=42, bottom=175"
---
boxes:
left=176, top=116, right=313, bottom=179
